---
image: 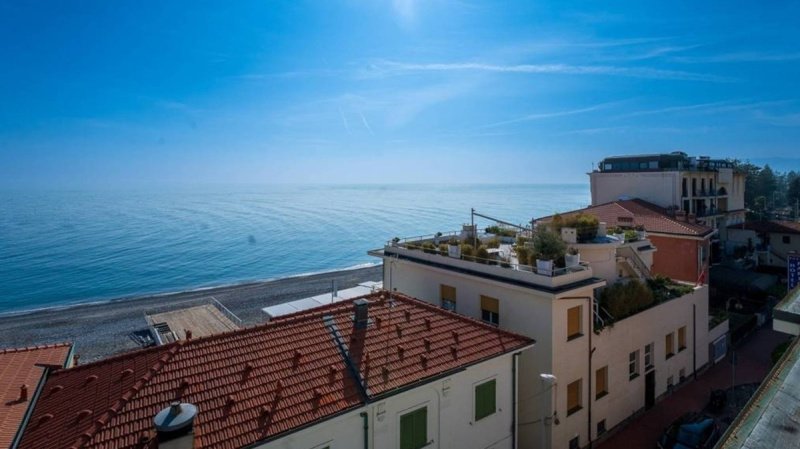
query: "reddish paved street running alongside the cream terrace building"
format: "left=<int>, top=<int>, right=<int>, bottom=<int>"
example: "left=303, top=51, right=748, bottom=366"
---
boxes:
left=595, top=322, right=789, bottom=449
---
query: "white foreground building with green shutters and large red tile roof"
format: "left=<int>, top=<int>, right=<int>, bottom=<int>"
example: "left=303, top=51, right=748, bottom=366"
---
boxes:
left=14, top=292, right=534, bottom=449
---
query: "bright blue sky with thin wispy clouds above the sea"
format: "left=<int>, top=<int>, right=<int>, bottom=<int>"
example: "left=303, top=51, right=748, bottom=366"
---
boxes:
left=0, top=0, right=800, bottom=188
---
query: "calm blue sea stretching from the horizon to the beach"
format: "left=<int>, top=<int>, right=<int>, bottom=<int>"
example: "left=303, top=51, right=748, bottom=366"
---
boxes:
left=0, top=185, right=590, bottom=313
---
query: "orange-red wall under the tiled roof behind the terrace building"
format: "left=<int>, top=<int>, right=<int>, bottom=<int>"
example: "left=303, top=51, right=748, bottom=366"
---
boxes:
left=648, top=234, right=710, bottom=282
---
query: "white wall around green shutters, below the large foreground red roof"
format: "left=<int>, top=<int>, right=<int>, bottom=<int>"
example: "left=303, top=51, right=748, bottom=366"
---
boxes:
left=259, top=349, right=530, bottom=449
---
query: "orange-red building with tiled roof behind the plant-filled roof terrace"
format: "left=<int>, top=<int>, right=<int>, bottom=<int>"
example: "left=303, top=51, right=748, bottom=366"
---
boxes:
left=536, top=198, right=716, bottom=283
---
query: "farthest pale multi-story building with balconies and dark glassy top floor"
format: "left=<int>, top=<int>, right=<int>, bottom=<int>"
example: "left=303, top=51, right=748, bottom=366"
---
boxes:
left=589, top=151, right=745, bottom=241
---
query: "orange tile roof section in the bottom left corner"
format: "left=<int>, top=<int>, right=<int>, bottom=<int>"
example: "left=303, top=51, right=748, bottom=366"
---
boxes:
left=0, top=343, right=72, bottom=449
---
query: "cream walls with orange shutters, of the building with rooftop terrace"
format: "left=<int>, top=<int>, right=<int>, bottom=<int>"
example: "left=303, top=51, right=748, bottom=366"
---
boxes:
left=371, top=226, right=724, bottom=449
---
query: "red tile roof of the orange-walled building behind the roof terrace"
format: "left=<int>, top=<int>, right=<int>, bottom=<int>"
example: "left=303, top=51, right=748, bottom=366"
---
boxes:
left=536, top=198, right=713, bottom=237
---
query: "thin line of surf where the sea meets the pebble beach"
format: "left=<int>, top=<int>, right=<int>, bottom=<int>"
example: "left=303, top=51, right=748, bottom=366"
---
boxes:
left=0, top=262, right=381, bottom=318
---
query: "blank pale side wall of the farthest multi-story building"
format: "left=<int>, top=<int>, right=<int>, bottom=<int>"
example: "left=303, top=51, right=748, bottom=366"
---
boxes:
left=589, top=172, right=681, bottom=207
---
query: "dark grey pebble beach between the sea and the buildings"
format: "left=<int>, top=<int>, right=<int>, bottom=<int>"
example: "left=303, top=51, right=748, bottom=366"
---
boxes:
left=0, top=264, right=383, bottom=362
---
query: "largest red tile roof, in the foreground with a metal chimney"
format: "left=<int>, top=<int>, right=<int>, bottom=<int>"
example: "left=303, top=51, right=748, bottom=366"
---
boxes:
left=20, top=293, right=533, bottom=449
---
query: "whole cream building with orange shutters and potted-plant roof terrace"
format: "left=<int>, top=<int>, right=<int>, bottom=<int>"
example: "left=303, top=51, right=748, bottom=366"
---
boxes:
left=369, top=223, right=728, bottom=448
